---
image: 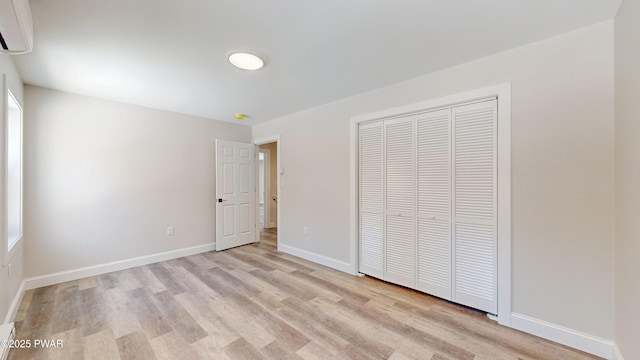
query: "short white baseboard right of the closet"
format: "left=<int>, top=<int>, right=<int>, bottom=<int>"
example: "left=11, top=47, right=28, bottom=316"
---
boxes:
left=511, top=313, right=619, bottom=360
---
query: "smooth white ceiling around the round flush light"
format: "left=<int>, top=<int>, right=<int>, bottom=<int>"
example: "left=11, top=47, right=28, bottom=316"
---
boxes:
left=15, top=0, right=620, bottom=125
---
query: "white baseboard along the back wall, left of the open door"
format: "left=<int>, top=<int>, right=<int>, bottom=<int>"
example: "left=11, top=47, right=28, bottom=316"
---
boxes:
left=24, top=244, right=215, bottom=290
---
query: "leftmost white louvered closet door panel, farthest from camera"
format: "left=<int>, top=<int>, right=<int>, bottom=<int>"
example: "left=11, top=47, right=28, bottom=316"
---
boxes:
left=359, top=122, right=384, bottom=278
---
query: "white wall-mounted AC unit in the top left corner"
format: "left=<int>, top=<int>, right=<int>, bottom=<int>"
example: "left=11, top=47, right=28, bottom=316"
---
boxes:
left=0, top=0, right=33, bottom=54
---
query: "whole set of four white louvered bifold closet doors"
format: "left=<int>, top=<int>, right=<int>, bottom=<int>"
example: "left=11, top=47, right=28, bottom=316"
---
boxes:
left=358, top=98, right=498, bottom=314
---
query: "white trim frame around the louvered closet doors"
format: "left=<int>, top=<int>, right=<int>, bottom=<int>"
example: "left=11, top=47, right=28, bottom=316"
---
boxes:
left=348, top=82, right=511, bottom=326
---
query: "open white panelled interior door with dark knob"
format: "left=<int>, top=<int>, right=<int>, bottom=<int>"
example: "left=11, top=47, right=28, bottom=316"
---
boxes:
left=216, top=139, right=256, bottom=251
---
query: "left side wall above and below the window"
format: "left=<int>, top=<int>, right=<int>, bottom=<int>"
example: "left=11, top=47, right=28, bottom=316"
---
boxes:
left=0, top=55, right=24, bottom=323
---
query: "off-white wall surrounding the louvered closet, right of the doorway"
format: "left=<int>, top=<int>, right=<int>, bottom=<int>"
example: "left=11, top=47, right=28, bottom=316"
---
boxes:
left=253, top=21, right=614, bottom=339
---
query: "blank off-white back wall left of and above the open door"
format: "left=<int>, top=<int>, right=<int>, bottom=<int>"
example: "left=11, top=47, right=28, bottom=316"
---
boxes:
left=24, top=86, right=251, bottom=276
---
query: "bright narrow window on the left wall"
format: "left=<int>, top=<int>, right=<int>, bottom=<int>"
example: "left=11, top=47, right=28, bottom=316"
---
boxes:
left=7, top=91, right=22, bottom=250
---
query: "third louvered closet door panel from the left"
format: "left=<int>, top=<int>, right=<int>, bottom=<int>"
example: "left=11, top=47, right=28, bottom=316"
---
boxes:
left=417, top=109, right=452, bottom=300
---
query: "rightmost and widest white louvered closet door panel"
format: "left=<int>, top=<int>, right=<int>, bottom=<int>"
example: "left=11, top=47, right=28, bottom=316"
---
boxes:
left=452, top=100, right=497, bottom=314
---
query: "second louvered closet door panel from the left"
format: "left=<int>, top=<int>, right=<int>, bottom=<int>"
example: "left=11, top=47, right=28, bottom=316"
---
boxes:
left=384, top=115, right=416, bottom=287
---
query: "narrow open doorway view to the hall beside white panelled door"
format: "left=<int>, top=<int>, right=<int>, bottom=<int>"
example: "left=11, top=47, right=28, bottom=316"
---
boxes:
left=254, top=136, right=282, bottom=249
